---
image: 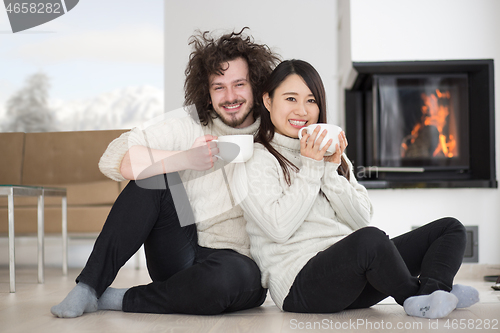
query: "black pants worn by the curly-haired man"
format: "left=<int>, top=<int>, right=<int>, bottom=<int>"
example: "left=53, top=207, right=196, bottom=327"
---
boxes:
left=77, top=173, right=267, bottom=315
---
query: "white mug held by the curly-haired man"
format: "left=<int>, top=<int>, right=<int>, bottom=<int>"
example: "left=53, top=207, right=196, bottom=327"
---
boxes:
left=212, top=134, right=253, bottom=163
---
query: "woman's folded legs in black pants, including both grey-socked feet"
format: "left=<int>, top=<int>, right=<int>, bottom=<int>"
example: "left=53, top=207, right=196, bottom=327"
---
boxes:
left=284, top=218, right=478, bottom=318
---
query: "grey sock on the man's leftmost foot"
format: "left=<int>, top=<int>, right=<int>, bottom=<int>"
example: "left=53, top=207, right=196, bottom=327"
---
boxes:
left=50, top=282, right=97, bottom=318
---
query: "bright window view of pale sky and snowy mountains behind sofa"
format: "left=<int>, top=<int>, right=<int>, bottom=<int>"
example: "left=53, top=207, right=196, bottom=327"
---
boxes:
left=0, top=0, right=163, bottom=132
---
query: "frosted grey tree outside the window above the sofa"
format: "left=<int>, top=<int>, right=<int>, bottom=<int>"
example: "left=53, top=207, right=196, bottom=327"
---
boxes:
left=3, top=72, right=56, bottom=132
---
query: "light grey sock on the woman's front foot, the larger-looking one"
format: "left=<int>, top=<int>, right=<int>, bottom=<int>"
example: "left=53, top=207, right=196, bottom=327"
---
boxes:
left=403, top=290, right=458, bottom=319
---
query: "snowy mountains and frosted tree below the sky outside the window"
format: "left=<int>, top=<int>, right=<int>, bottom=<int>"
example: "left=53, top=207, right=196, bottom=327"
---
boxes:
left=0, top=73, right=164, bottom=132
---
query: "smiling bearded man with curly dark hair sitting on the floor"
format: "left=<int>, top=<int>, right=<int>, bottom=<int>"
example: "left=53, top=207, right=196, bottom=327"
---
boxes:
left=51, top=28, right=279, bottom=317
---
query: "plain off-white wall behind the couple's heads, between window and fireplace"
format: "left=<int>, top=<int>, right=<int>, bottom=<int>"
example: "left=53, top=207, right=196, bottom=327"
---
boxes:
left=165, top=0, right=339, bottom=123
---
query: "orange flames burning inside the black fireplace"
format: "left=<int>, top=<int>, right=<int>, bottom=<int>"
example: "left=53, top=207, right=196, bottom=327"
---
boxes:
left=401, top=89, right=457, bottom=158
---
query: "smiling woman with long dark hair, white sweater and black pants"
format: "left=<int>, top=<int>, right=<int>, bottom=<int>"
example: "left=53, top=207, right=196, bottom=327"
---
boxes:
left=235, top=60, right=478, bottom=318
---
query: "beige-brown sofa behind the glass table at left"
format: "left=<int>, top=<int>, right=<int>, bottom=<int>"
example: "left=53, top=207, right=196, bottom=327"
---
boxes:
left=0, top=130, right=126, bottom=235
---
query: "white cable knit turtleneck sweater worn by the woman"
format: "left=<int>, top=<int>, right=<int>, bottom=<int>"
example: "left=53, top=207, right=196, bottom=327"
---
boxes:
left=234, top=133, right=372, bottom=309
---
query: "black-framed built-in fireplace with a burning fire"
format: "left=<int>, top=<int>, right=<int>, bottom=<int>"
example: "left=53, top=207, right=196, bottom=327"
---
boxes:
left=345, top=60, right=497, bottom=188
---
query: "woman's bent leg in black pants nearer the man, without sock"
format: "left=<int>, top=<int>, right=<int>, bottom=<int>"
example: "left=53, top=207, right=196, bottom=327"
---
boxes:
left=283, top=227, right=420, bottom=313
